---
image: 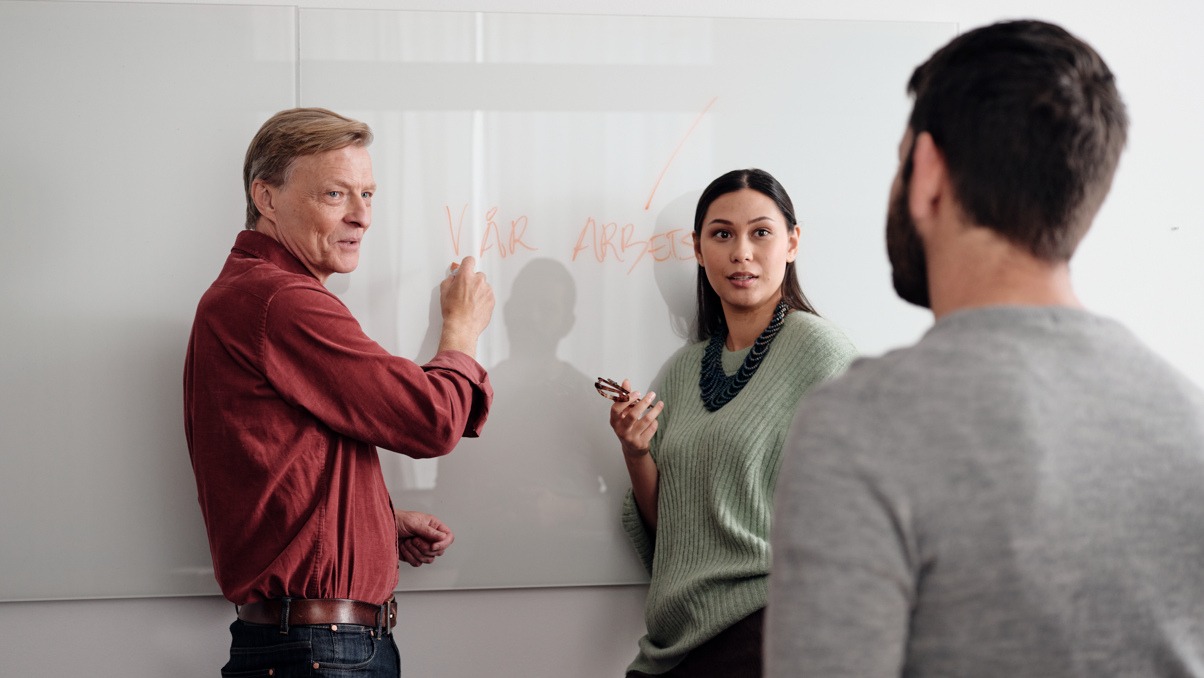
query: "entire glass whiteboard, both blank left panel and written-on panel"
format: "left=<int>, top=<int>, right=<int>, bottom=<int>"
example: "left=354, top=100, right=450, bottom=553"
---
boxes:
left=0, top=1, right=955, bottom=600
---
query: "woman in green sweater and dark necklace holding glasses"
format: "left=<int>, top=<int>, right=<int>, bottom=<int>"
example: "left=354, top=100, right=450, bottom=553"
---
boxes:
left=610, top=170, right=855, bottom=678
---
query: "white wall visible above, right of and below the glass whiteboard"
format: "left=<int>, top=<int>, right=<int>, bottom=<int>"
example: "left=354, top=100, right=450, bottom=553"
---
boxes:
left=0, top=0, right=1204, bottom=678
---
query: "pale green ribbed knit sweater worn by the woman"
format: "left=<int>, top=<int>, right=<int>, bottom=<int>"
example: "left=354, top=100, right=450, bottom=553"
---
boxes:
left=622, top=312, right=856, bottom=674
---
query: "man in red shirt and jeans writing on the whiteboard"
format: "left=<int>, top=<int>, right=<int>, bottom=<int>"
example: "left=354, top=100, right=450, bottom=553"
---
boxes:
left=184, top=108, right=494, bottom=677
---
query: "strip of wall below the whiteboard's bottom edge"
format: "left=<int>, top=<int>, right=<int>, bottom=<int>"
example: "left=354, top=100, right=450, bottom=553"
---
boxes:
left=0, top=586, right=644, bottom=678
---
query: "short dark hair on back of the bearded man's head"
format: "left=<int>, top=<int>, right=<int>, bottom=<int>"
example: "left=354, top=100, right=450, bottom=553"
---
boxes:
left=908, top=22, right=1128, bottom=261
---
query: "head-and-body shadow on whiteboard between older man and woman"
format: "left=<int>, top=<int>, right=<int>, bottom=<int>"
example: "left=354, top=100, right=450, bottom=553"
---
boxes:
left=431, top=259, right=645, bottom=588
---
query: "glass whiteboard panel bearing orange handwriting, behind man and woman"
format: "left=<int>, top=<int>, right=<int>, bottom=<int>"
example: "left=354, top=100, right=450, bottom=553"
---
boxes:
left=301, top=10, right=955, bottom=589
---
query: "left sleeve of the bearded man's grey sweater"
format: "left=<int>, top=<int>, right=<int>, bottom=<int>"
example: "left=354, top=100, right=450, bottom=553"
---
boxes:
left=765, top=380, right=917, bottom=678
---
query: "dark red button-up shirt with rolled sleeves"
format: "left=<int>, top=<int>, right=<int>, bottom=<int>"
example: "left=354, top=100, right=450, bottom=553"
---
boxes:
left=184, top=231, right=492, bottom=605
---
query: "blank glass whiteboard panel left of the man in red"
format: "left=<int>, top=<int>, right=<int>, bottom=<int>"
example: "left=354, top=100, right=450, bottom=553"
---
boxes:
left=0, top=2, right=296, bottom=600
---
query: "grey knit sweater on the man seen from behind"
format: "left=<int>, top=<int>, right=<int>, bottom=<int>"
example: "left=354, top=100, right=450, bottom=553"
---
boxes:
left=766, top=307, right=1204, bottom=678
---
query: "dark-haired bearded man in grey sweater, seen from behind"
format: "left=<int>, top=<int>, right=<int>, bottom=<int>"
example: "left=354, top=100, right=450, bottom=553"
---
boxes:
left=766, top=22, right=1204, bottom=678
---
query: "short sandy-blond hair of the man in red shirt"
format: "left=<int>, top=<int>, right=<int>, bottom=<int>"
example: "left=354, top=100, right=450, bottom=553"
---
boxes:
left=242, top=108, right=372, bottom=229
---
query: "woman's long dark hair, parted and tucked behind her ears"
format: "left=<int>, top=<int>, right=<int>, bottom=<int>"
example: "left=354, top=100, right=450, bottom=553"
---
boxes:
left=694, top=169, right=819, bottom=340
